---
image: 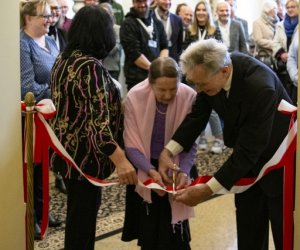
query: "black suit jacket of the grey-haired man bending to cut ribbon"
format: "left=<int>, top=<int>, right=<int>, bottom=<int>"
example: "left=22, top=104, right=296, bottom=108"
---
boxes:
left=173, top=53, right=291, bottom=194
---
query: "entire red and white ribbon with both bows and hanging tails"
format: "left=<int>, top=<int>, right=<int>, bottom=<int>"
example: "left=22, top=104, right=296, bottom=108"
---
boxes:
left=21, top=99, right=297, bottom=249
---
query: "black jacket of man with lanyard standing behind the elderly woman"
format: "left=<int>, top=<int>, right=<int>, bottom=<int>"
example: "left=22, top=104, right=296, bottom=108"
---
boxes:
left=120, top=8, right=168, bottom=88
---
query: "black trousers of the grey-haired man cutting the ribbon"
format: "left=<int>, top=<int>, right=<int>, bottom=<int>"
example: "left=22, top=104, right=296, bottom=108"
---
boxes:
left=235, top=184, right=283, bottom=250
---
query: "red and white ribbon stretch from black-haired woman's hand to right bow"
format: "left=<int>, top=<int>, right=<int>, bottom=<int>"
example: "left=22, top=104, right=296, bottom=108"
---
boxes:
left=139, top=100, right=297, bottom=250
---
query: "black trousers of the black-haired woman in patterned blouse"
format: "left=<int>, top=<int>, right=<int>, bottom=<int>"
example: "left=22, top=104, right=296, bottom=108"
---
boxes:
left=65, top=179, right=102, bottom=250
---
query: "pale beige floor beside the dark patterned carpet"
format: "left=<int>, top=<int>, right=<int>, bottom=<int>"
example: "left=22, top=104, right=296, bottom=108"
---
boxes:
left=95, top=195, right=275, bottom=250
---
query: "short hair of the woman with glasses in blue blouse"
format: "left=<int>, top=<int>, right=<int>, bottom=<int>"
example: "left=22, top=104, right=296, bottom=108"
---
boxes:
left=20, top=0, right=50, bottom=29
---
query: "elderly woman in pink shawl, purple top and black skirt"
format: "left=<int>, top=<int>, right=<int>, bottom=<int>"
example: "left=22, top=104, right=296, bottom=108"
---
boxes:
left=122, top=57, right=196, bottom=250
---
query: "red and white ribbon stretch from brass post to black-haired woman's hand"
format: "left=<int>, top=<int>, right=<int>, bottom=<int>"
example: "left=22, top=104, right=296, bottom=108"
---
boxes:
left=21, top=99, right=118, bottom=238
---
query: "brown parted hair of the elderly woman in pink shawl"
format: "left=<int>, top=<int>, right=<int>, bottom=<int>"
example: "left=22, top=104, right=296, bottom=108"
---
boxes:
left=148, top=57, right=181, bottom=84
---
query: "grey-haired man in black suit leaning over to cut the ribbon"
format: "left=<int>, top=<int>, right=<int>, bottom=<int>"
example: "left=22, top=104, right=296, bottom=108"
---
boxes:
left=159, top=39, right=291, bottom=250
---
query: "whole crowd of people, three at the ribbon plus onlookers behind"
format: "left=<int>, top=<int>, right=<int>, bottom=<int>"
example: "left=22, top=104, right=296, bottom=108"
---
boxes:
left=20, top=0, right=299, bottom=250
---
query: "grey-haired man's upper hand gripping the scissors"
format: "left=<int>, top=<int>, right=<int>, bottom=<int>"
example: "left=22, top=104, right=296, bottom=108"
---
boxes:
left=158, top=149, right=178, bottom=185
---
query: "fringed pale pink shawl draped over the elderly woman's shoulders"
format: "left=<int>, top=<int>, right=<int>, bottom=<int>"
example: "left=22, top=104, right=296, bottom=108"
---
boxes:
left=124, top=79, right=196, bottom=224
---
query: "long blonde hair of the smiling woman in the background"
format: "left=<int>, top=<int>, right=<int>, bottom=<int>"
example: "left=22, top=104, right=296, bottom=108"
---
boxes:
left=190, top=0, right=216, bottom=36
